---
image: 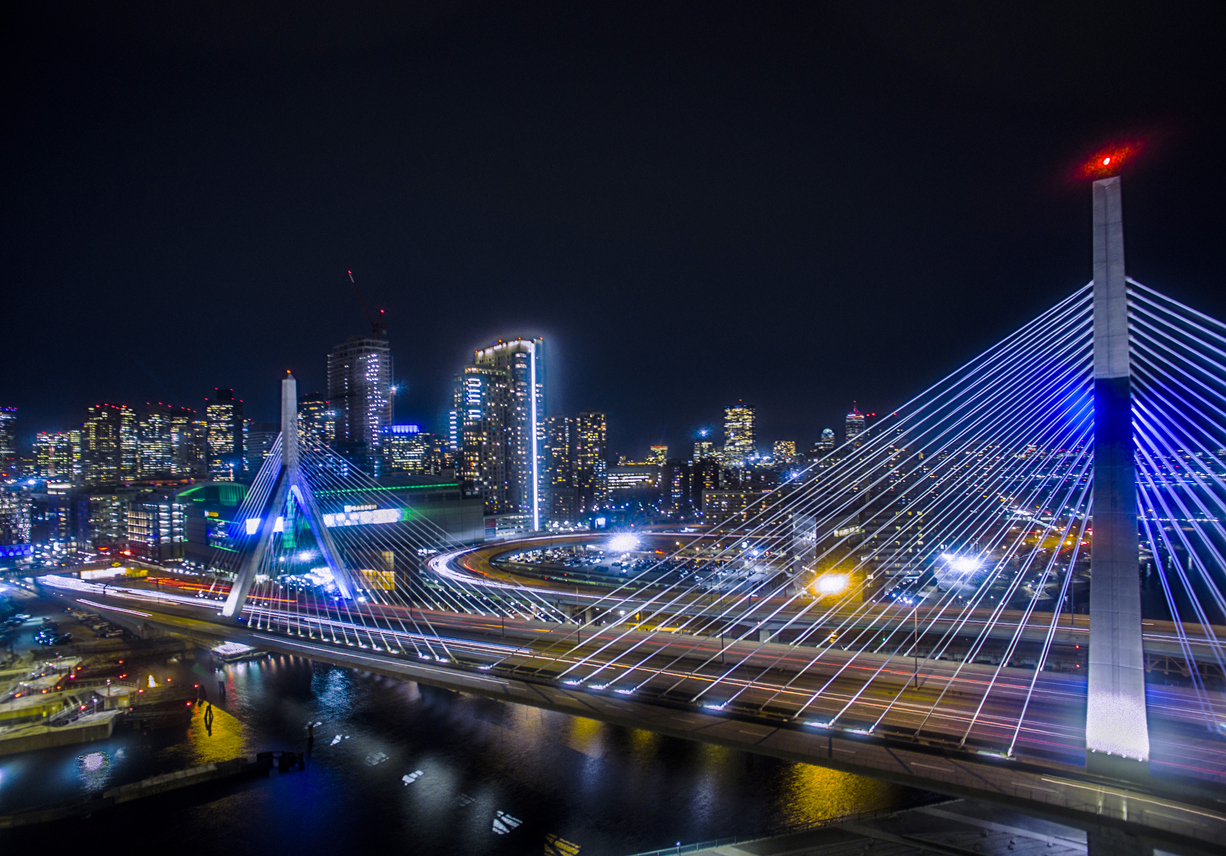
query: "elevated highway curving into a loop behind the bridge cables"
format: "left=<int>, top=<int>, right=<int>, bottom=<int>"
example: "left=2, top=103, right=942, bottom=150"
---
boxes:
left=432, top=533, right=1226, bottom=677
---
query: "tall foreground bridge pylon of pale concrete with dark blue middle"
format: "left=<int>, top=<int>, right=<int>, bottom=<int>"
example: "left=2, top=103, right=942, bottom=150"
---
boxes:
left=1085, top=177, right=1149, bottom=776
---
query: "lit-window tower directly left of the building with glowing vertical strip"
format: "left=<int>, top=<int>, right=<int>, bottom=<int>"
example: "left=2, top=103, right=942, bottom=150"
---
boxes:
left=452, top=365, right=510, bottom=514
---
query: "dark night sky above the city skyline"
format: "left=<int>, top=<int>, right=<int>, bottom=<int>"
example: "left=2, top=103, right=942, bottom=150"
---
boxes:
left=0, top=0, right=1226, bottom=457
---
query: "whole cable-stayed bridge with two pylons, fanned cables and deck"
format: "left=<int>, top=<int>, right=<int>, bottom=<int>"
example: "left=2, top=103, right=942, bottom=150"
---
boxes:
left=35, top=179, right=1226, bottom=850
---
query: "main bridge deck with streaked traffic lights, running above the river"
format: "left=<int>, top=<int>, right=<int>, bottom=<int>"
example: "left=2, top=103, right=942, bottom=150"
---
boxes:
left=33, top=580, right=1226, bottom=854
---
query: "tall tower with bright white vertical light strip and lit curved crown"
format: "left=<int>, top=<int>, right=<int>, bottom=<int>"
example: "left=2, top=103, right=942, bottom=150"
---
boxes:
left=473, top=338, right=548, bottom=530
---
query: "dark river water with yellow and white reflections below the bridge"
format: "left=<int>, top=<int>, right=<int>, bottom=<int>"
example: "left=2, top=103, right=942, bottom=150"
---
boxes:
left=0, top=656, right=920, bottom=856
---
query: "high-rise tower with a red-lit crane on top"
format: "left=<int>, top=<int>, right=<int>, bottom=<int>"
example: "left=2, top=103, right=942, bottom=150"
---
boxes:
left=327, top=336, right=392, bottom=475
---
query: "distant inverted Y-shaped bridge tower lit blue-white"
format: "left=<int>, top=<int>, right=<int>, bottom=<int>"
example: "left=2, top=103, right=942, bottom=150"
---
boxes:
left=222, top=372, right=354, bottom=618
